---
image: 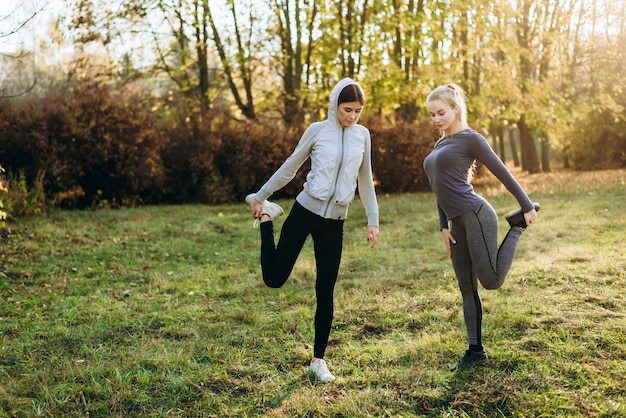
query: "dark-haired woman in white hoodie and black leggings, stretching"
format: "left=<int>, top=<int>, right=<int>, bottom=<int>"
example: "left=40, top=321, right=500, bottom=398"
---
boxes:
left=246, top=78, right=378, bottom=382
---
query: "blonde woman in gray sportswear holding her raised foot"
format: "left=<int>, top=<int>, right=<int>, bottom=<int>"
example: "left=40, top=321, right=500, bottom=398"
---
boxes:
left=424, top=84, right=539, bottom=368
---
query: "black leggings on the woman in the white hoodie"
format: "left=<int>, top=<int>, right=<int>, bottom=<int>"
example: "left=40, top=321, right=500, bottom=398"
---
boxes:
left=260, top=202, right=344, bottom=358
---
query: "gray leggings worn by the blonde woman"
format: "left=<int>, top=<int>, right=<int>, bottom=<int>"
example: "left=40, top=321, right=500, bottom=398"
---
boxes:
left=450, top=202, right=523, bottom=345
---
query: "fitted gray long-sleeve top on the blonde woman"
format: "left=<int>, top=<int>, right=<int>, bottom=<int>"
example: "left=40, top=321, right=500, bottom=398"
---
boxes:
left=424, top=129, right=534, bottom=229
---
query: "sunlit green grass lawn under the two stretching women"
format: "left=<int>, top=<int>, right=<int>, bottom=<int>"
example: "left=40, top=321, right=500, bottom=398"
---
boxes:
left=0, top=170, right=626, bottom=417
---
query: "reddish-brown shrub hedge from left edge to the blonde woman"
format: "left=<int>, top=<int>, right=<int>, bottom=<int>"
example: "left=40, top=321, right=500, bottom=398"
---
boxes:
left=0, top=83, right=434, bottom=214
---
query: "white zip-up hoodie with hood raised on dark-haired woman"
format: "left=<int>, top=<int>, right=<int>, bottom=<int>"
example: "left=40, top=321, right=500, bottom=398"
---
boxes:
left=255, top=78, right=378, bottom=226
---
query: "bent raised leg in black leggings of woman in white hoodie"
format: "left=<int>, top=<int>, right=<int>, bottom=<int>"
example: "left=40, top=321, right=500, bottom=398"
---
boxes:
left=260, top=202, right=311, bottom=288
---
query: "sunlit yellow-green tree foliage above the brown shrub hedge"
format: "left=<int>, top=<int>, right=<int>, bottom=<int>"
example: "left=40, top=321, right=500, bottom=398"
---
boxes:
left=50, top=0, right=624, bottom=170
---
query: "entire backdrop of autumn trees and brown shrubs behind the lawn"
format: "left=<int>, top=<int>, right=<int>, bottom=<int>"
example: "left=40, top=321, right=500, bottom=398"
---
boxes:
left=0, top=0, right=626, bottom=216
